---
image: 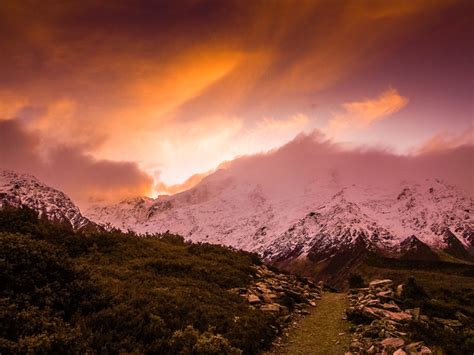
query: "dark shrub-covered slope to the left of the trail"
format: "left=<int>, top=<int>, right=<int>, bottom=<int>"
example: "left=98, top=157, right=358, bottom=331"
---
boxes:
left=0, top=209, right=274, bottom=354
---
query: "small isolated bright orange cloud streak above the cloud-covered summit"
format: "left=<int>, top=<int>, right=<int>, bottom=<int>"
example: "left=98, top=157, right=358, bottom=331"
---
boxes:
left=329, top=89, right=408, bottom=132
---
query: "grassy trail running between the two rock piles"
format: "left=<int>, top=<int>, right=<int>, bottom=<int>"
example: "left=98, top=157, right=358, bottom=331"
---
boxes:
left=266, top=292, right=350, bottom=355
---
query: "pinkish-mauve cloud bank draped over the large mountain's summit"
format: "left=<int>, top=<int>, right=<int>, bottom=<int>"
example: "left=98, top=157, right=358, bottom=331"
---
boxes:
left=215, top=132, right=474, bottom=196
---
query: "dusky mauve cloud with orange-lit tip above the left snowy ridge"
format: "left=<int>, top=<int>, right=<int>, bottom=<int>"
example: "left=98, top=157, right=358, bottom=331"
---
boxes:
left=0, top=120, right=153, bottom=205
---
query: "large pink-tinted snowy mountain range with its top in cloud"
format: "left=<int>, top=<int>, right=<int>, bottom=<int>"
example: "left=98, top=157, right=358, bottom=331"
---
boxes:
left=86, top=170, right=474, bottom=261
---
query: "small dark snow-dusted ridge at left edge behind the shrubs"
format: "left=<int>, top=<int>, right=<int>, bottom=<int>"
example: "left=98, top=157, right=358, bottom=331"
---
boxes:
left=0, top=170, right=94, bottom=230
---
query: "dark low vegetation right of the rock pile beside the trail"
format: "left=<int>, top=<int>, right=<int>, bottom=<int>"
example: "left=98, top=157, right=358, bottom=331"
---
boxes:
left=348, top=256, right=474, bottom=354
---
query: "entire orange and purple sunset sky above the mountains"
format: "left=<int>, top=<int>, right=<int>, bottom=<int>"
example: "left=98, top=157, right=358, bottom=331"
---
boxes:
left=0, top=0, right=474, bottom=202
